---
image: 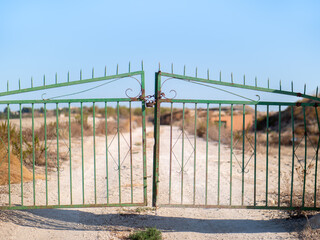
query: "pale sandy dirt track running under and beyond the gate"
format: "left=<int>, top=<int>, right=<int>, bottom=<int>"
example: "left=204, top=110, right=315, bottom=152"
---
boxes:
left=0, top=126, right=316, bottom=239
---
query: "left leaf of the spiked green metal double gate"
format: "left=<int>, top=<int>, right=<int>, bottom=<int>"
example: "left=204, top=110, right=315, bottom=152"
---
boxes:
left=0, top=64, right=147, bottom=209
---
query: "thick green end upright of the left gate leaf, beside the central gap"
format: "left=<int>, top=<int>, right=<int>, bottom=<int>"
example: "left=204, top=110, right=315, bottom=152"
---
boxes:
left=141, top=71, right=148, bottom=206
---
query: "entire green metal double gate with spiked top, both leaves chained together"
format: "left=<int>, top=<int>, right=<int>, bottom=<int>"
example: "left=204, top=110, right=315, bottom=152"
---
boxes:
left=0, top=64, right=320, bottom=210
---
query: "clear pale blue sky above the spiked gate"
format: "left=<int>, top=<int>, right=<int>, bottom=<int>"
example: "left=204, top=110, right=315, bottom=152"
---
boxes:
left=0, top=0, right=320, bottom=101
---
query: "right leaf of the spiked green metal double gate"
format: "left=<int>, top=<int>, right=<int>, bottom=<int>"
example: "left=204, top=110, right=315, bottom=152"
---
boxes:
left=152, top=67, right=320, bottom=210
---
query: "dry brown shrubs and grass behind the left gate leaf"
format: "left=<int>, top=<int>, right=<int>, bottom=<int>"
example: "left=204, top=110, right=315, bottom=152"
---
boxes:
left=0, top=106, right=142, bottom=185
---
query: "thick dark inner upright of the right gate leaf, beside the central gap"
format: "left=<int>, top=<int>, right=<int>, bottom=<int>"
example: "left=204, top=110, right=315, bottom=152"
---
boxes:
left=152, top=71, right=161, bottom=207
